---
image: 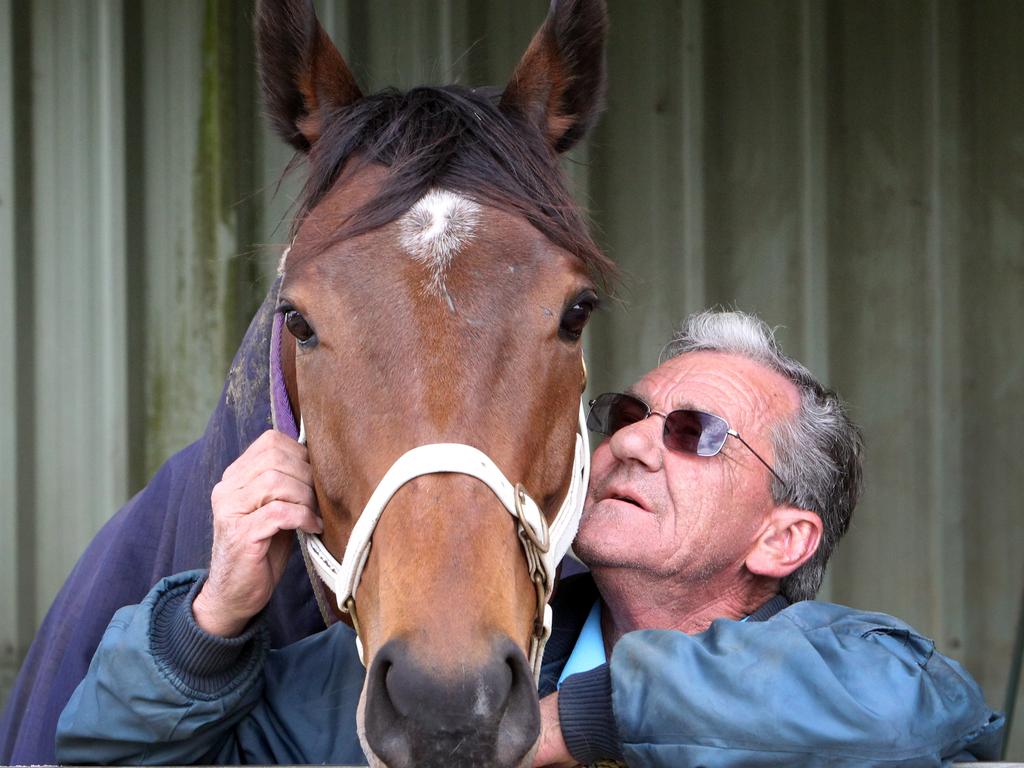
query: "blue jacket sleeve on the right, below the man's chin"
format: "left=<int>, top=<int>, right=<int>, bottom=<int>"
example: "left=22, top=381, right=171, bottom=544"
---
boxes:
left=559, top=603, right=1004, bottom=767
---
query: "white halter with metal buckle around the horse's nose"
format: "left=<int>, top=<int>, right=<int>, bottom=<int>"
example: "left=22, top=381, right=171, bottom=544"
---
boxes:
left=299, top=400, right=590, bottom=681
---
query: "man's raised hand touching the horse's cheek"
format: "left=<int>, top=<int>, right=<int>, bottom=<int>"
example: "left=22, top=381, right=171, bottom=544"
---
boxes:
left=193, top=430, right=324, bottom=637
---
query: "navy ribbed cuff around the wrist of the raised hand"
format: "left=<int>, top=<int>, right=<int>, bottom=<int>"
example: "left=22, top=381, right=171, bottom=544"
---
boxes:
left=150, top=575, right=266, bottom=697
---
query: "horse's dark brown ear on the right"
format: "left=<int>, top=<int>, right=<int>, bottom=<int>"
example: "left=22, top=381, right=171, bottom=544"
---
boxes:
left=501, top=0, right=608, bottom=152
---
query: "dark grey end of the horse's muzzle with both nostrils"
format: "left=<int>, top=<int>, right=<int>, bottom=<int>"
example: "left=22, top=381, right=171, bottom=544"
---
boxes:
left=365, top=639, right=540, bottom=768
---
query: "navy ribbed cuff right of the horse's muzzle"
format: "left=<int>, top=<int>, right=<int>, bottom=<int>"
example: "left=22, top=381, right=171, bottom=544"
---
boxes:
left=558, top=664, right=625, bottom=765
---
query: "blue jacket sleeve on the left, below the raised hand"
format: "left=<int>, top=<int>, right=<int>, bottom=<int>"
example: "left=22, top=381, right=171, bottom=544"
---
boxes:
left=56, top=571, right=272, bottom=765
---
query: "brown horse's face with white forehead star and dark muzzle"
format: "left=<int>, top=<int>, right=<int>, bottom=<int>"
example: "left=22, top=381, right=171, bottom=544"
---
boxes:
left=281, top=174, right=597, bottom=765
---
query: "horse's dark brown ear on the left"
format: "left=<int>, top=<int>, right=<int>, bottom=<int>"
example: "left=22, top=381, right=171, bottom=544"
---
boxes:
left=256, top=0, right=362, bottom=152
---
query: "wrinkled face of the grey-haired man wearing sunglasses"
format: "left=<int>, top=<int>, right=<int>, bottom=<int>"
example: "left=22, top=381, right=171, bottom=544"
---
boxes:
left=573, top=352, right=799, bottom=579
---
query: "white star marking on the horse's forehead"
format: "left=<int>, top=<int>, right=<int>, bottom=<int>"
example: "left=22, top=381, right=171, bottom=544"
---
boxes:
left=398, top=189, right=480, bottom=303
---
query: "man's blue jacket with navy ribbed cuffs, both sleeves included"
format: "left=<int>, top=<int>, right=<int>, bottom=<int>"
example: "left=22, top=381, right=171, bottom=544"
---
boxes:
left=56, top=571, right=1004, bottom=768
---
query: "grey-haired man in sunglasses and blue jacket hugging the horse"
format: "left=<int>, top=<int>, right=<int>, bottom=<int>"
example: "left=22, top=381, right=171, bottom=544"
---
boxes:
left=58, top=312, right=1002, bottom=766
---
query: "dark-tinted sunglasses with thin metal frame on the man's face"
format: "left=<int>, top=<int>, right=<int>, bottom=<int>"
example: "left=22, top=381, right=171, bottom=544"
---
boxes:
left=587, top=392, right=788, bottom=493
